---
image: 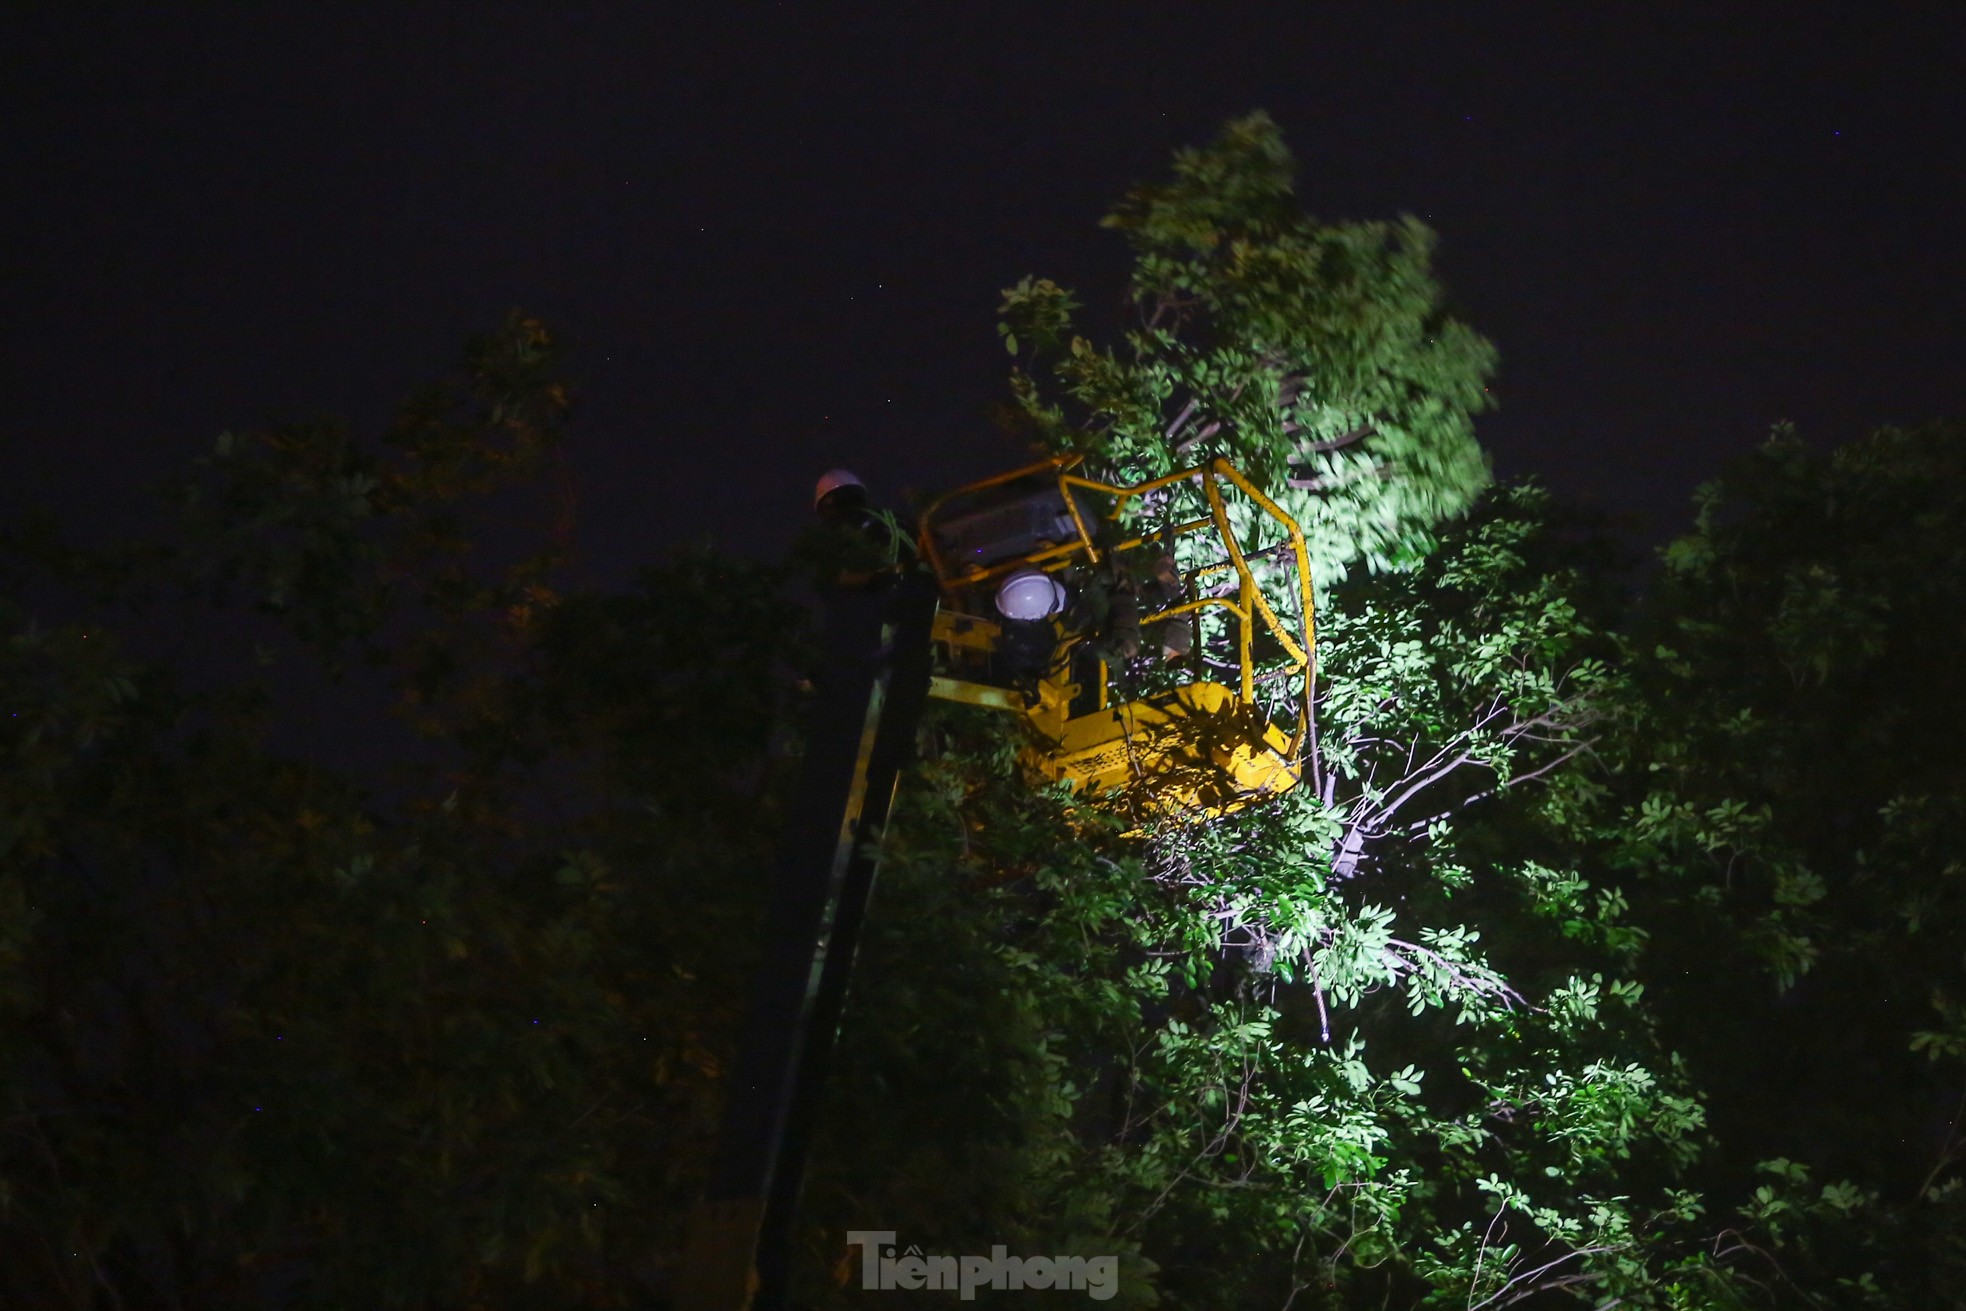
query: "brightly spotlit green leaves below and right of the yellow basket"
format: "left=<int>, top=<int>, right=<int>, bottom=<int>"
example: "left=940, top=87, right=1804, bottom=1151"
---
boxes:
left=912, top=477, right=1730, bottom=1305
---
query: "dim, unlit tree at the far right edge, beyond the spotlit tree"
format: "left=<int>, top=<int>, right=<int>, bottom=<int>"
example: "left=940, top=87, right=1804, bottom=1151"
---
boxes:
left=1604, top=423, right=1966, bottom=1307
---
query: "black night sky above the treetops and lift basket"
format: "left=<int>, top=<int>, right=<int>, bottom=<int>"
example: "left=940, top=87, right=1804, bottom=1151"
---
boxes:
left=0, top=4, right=1966, bottom=582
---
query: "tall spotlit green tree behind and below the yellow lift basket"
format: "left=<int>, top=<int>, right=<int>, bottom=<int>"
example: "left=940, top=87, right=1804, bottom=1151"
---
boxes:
left=790, top=116, right=1728, bottom=1307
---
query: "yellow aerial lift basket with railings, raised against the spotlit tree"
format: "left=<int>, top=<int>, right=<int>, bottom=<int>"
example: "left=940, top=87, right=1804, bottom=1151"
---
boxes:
left=922, top=460, right=1315, bottom=822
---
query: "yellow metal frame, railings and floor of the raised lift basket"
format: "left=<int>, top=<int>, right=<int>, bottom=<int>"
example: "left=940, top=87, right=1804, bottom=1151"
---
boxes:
left=922, top=458, right=1317, bottom=816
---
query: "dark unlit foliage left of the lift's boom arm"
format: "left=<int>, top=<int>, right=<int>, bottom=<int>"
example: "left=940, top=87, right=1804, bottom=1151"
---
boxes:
left=0, top=316, right=782, bottom=1307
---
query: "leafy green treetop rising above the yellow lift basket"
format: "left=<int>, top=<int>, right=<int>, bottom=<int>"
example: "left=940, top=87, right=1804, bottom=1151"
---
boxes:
left=999, top=114, right=1494, bottom=582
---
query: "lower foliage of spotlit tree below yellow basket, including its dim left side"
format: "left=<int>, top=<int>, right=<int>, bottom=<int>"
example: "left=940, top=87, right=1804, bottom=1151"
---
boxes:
left=798, top=489, right=1722, bottom=1307
